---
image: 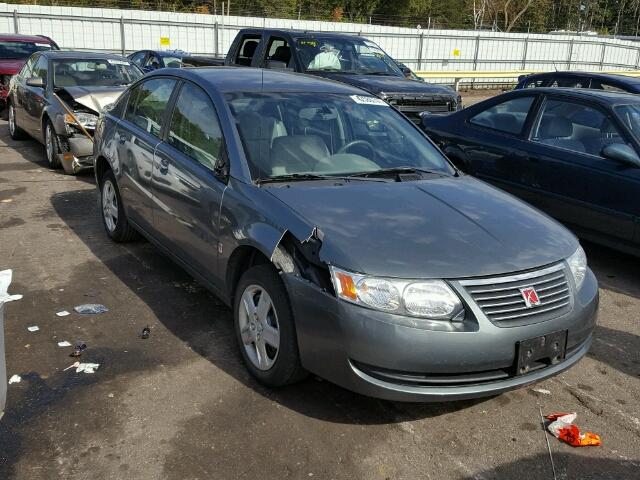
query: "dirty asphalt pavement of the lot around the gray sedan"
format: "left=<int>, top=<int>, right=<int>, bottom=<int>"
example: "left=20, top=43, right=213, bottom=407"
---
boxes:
left=0, top=117, right=640, bottom=480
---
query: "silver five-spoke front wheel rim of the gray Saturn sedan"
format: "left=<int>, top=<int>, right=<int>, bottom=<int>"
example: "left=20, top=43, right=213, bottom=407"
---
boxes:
left=238, top=285, right=280, bottom=370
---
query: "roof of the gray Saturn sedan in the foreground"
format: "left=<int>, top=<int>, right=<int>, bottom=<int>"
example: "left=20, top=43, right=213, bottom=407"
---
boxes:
left=146, top=67, right=370, bottom=96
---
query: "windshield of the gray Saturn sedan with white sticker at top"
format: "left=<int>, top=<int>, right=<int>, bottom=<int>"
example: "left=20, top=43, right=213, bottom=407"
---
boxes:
left=227, top=93, right=454, bottom=180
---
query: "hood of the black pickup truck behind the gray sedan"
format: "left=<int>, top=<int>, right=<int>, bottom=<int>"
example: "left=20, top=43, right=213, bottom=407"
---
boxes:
left=314, top=72, right=456, bottom=97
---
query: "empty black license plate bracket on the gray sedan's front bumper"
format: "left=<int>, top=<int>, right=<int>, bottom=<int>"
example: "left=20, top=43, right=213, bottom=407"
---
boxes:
left=516, top=330, right=567, bottom=375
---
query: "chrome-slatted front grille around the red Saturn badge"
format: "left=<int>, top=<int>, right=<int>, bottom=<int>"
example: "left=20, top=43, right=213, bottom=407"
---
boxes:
left=460, top=264, right=572, bottom=327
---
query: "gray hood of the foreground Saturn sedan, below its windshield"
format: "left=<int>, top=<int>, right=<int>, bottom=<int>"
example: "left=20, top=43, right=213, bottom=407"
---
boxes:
left=266, top=176, right=578, bottom=278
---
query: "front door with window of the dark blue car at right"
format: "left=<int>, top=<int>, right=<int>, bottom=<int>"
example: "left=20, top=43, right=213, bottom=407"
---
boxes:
left=530, top=95, right=640, bottom=241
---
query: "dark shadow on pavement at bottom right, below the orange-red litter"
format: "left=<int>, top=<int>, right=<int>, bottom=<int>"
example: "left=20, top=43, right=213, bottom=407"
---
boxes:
left=464, top=454, right=640, bottom=480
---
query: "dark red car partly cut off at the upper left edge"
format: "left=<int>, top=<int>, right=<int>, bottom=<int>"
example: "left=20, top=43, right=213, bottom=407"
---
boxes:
left=0, top=34, right=60, bottom=110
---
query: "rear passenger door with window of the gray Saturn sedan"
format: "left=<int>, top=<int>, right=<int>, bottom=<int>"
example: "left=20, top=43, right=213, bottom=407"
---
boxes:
left=116, top=77, right=177, bottom=232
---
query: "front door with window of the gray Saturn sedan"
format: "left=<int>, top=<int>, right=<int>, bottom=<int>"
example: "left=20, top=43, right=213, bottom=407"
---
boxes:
left=153, top=81, right=226, bottom=286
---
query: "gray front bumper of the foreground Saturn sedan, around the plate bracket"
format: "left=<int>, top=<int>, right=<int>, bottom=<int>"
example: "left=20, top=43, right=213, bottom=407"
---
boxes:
left=284, top=271, right=599, bottom=402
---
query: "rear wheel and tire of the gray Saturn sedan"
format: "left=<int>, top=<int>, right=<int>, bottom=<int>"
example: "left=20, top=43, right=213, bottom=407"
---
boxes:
left=100, top=170, right=138, bottom=243
